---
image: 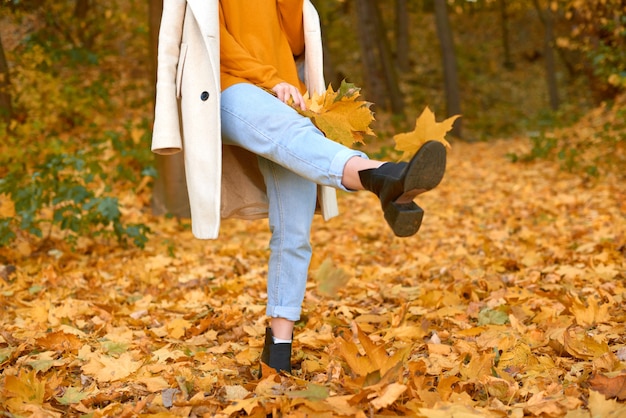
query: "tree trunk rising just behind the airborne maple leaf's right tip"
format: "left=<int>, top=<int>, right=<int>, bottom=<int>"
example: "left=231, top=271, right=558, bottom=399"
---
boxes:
left=435, top=0, right=461, bottom=138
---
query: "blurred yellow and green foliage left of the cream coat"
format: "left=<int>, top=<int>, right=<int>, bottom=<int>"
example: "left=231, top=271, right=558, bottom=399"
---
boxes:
left=0, top=0, right=155, bottom=246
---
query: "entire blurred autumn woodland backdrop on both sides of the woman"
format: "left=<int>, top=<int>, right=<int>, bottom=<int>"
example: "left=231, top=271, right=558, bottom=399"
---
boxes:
left=0, top=0, right=626, bottom=245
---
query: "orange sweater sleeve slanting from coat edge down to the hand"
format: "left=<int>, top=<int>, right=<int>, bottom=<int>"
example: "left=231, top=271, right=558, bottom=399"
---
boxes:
left=220, top=3, right=283, bottom=89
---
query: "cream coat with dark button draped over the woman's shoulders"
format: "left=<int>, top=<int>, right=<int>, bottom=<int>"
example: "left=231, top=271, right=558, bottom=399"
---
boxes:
left=152, top=0, right=337, bottom=239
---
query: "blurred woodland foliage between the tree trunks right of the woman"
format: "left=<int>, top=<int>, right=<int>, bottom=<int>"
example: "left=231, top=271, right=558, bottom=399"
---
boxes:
left=315, top=0, right=626, bottom=140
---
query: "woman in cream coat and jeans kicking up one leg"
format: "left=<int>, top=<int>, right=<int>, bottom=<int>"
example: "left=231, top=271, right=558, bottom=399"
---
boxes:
left=152, top=0, right=446, bottom=372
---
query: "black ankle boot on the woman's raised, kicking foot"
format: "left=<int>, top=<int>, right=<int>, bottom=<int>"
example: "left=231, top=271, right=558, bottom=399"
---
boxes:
left=359, top=141, right=446, bottom=237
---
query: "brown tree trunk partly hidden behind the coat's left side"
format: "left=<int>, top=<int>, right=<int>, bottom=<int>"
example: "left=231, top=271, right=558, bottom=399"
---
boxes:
left=149, top=0, right=190, bottom=218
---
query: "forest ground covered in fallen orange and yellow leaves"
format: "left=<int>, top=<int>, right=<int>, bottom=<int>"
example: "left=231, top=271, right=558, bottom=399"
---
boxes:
left=0, top=132, right=626, bottom=417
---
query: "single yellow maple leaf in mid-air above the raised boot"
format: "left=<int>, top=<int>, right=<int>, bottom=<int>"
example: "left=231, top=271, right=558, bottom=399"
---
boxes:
left=393, top=107, right=461, bottom=158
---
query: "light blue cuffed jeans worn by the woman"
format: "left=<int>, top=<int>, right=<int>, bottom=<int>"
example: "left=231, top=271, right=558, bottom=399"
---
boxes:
left=221, top=83, right=367, bottom=321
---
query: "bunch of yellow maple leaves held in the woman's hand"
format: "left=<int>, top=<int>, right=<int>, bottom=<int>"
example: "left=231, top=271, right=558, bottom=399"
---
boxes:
left=299, top=81, right=374, bottom=146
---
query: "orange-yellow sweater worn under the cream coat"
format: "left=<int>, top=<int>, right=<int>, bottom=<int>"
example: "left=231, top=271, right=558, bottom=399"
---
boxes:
left=220, top=0, right=306, bottom=93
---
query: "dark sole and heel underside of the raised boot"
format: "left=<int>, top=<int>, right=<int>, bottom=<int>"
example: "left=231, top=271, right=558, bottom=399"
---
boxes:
left=383, top=141, right=446, bottom=237
